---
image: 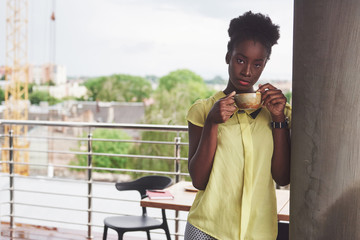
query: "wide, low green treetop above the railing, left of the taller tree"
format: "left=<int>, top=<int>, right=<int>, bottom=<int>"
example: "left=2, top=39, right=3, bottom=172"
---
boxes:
left=84, top=74, right=152, bottom=102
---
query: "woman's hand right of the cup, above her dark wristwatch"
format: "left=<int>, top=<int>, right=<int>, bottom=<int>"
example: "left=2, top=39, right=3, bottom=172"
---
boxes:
left=257, top=83, right=287, bottom=122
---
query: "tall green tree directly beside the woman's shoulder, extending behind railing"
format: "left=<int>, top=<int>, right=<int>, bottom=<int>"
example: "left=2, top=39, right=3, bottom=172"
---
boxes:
left=132, top=69, right=214, bottom=179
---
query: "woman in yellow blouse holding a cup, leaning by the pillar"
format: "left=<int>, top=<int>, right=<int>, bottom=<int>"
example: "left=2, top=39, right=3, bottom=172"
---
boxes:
left=185, top=12, right=291, bottom=240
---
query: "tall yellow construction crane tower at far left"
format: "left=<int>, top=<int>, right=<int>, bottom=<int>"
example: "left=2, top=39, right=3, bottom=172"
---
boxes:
left=2, top=0, right=30, bottom=175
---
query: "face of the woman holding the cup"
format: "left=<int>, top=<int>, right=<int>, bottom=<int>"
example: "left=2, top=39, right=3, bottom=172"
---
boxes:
left=226, top=40, right=268, bottom=93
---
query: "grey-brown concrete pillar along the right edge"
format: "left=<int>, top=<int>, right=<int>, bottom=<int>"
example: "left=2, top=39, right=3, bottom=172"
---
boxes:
left=290, top=0, right=360, bottom=240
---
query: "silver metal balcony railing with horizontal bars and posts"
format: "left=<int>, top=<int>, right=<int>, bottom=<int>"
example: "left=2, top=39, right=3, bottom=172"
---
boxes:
left=0, top=119, right=189, bottom=239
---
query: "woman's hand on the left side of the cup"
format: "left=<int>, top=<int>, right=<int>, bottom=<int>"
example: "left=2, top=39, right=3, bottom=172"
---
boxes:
left=207, top=91, right=236, bottom=124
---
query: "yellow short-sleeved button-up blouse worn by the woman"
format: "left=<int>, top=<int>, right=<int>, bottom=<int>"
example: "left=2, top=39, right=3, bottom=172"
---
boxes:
left=187, top=92, right=291, bottom=240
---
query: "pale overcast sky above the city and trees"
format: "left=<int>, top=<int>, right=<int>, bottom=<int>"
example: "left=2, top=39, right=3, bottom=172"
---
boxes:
left=0, top=0, right=293, bottom=80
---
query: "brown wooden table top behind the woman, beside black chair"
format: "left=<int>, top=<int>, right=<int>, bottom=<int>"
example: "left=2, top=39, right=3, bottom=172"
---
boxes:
left=140, top=182, right=290, bottom=221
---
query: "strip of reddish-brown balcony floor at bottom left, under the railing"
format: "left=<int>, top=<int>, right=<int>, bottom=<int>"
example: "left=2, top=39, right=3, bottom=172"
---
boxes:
left=0, top=222, right=145, bottom=240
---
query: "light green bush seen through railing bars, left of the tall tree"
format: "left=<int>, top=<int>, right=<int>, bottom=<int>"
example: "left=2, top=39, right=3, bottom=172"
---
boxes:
left=72, top=129, right=132, bottom=172
